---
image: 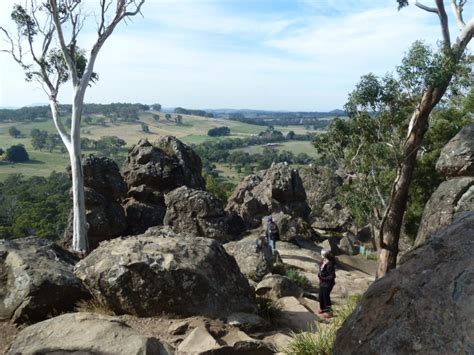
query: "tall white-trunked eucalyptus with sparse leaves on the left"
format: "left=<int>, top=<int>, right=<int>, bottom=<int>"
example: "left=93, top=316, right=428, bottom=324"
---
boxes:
left=0, top=0, right=145, bottom=253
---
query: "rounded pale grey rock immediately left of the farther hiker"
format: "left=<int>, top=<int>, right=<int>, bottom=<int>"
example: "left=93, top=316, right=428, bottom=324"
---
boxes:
left=224, top=235, right=273, bottom=282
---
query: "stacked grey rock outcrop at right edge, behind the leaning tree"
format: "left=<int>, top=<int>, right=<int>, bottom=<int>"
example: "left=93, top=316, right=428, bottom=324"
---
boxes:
left=415, top=125, right=474, bottom=246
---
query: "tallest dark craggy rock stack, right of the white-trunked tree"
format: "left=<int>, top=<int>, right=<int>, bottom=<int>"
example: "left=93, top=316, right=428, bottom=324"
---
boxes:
left=122, top=136, right=206, bottom=234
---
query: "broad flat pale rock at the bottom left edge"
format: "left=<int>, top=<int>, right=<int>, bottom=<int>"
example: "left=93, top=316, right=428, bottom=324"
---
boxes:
left=8, top=313, right=173, bottom=355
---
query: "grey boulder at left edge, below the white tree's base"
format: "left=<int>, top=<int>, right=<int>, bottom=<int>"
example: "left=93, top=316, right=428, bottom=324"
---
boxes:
left=0, top=237, right=90, bottom=323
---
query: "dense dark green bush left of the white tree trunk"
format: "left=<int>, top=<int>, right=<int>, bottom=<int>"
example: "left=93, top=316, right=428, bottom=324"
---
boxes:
left=0, top=173, right=71, bottom=240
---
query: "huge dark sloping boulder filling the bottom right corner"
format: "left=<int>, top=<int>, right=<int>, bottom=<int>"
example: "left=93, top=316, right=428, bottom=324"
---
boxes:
left=334, top=212, right=474, bottom=355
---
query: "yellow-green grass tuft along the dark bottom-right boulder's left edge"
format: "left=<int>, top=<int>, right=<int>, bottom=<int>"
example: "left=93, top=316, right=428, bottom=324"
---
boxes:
left=282, top=295, right=360, bottom=355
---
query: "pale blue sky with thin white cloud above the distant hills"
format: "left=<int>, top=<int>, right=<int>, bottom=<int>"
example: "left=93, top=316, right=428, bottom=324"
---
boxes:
left=0, top=0, right=474, bottom=111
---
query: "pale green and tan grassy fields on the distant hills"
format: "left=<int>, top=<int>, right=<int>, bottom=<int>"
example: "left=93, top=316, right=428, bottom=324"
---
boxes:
left=0, top=113, right=315, bottom=181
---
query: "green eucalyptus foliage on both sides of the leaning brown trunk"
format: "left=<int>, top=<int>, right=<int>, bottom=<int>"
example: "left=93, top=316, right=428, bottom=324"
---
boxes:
left=314, top=42, right=470, bottom=237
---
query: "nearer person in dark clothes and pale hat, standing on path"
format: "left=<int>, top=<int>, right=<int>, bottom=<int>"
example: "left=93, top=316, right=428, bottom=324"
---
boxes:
left=318, top=249, right=336, bottom=317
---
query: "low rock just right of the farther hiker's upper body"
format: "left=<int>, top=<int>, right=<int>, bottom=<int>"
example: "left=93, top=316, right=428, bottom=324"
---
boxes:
left=262, top=212, right=317, bottom=242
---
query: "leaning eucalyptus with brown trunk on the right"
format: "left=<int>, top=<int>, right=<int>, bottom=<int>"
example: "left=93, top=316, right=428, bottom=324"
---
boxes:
left=377, top=0, right=474, bottom=277
